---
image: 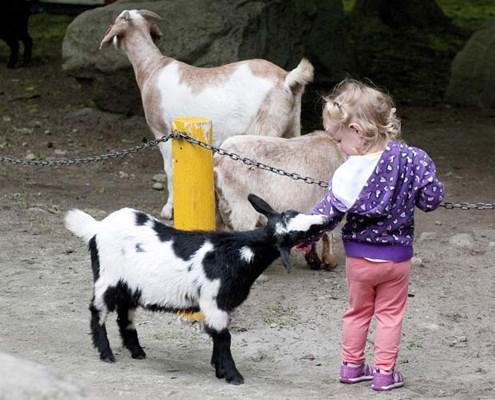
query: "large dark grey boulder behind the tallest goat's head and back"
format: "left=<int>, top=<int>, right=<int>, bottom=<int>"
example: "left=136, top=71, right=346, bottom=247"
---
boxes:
left=62, top=0, right=346, bottom=114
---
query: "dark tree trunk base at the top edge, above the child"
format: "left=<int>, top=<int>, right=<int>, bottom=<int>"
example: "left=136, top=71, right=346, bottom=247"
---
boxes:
left=354, top=0, right=451, bottom=29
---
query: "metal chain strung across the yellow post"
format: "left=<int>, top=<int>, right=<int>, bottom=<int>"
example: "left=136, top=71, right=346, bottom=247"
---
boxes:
left=0, top=131, right=495, bottom=210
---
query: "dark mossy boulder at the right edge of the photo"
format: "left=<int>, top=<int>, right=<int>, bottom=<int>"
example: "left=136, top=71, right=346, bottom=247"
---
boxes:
left=445, top=19, right=495, bottom=108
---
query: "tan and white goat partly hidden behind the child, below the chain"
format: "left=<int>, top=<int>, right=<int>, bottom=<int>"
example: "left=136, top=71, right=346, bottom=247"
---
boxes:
left=213, top=131, right=345, bottom=270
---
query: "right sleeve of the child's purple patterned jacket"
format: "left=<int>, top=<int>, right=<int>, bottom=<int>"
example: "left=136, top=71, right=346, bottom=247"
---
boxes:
left=416, top=153, right=444, bottom=211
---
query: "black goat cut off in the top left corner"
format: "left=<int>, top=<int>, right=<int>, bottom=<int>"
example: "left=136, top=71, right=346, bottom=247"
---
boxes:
left=0, top=0, right=33, bottom=68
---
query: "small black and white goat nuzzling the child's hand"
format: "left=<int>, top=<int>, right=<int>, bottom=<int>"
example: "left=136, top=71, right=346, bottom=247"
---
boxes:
left=65, top=194, right=328, bottom=384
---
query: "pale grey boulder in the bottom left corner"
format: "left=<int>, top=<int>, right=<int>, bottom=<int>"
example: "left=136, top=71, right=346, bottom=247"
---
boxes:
left=0, top=353, right=88, bottom=400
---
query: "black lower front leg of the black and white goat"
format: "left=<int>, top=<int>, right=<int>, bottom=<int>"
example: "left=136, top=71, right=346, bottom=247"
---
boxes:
left=206, top=326, right=244, bottom=385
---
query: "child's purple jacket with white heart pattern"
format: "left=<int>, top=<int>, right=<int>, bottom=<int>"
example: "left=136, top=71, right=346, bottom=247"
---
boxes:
left=304, top=142, right=444, bottom=261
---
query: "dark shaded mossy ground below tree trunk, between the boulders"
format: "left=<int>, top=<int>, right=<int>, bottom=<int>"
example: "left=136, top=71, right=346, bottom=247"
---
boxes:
left=343, top=0, right=495, bottom=105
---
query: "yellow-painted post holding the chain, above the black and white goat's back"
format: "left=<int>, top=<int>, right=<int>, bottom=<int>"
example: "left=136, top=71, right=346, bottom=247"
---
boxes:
left=172, top=117, right=215, bottom=230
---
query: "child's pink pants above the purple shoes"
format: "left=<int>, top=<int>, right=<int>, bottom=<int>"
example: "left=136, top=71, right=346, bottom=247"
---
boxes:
left=341, top=257, right=411, bottom=370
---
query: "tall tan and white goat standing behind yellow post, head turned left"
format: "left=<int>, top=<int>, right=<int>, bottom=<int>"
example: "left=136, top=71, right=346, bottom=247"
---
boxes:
left=100, top=10, right=313, bottom=219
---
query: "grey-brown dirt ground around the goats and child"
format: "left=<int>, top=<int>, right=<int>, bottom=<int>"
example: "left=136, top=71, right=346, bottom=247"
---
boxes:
left=0, top=29, right=495, bottom=399
